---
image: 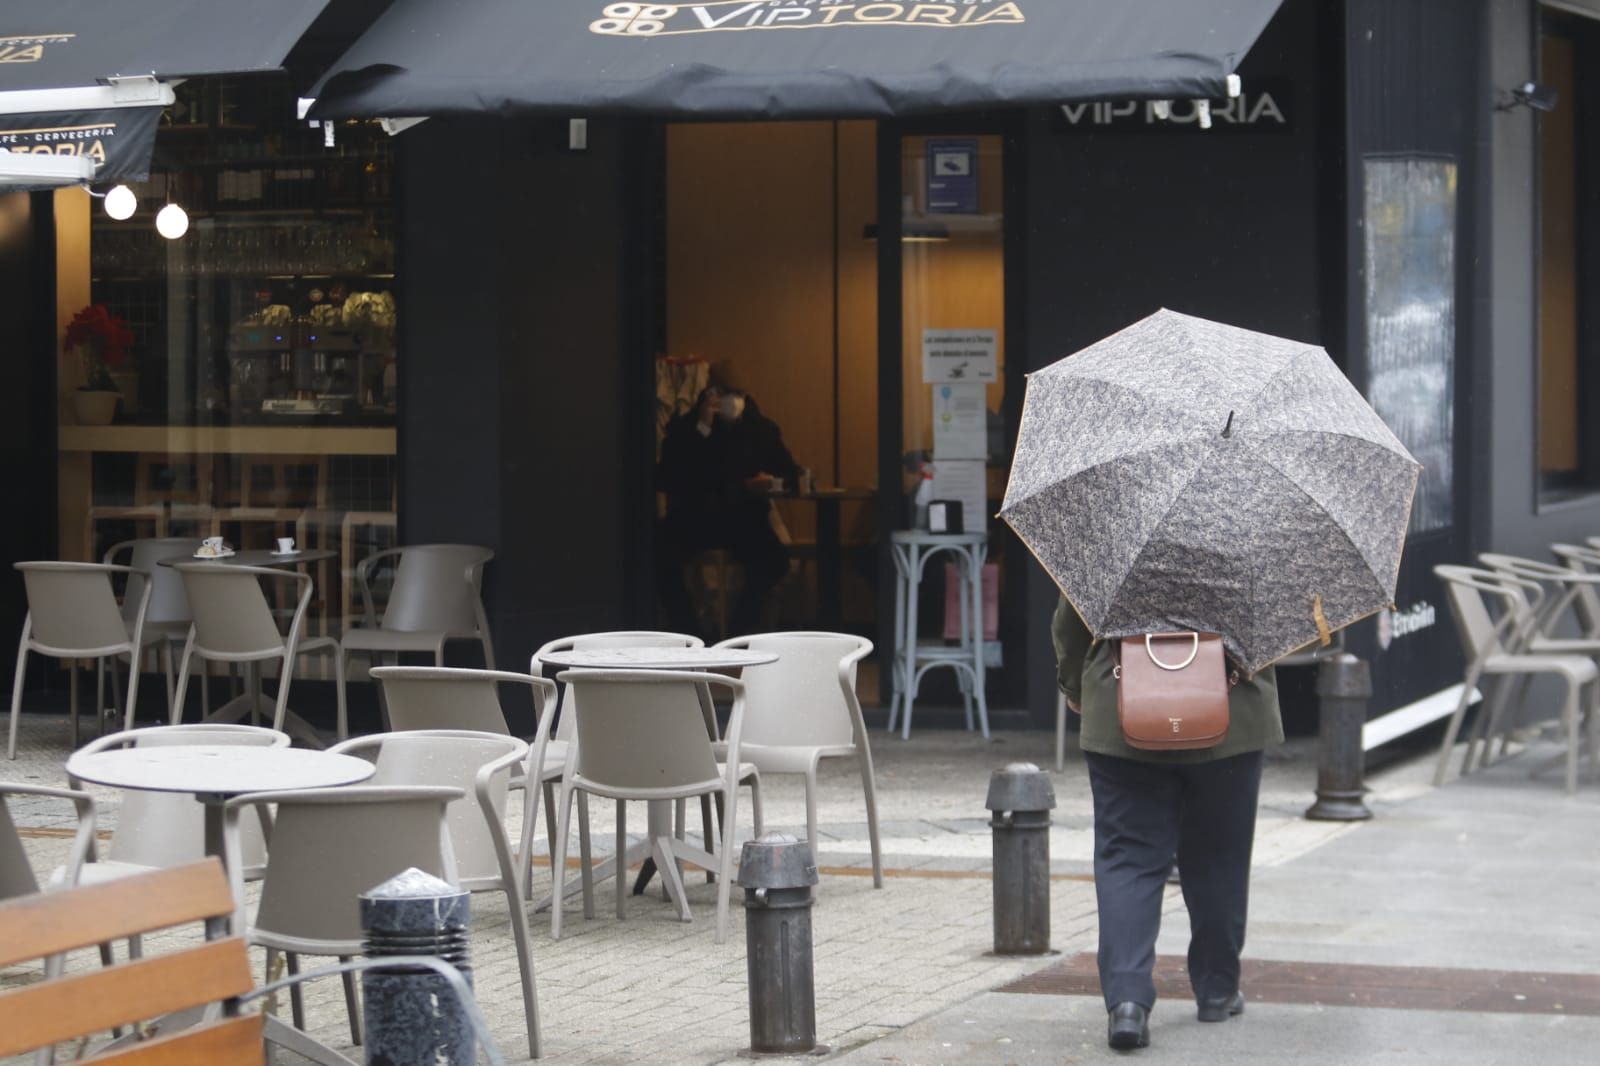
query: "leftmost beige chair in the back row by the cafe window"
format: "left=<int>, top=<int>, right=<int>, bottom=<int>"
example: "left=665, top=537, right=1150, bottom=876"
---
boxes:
left=6, top=562, right=150, bottom=759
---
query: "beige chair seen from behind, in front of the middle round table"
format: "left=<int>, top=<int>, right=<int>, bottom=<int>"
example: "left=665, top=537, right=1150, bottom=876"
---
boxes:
left=550, top=671, right=762, bottom=944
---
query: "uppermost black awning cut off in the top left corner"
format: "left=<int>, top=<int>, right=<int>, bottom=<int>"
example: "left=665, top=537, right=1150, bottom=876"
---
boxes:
left=0, top=0, right=334, bottom=93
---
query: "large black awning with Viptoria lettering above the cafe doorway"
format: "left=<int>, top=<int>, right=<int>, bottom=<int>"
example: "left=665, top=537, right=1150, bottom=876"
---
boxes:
left=307, top=0, right=1280, bottom=118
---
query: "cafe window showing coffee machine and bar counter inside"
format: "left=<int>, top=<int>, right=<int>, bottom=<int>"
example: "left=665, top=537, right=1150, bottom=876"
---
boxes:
left=56, top=75, right=398, bottom=646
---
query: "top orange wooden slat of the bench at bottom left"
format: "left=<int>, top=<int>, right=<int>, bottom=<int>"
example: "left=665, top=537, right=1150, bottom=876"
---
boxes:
left=0, top=858, right=234, bottom=967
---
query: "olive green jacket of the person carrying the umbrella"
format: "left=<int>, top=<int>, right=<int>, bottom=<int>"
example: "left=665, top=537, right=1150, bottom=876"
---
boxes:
left=1050, top=597, right=1283, bottom=762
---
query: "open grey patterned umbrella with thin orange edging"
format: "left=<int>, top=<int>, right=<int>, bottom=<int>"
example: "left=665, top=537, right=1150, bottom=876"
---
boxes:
left=1000, top=311, right=1421, bottom=672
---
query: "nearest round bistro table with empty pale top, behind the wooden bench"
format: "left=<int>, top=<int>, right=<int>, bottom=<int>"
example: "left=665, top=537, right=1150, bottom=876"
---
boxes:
left=67, top=744, right=378, bottom=1063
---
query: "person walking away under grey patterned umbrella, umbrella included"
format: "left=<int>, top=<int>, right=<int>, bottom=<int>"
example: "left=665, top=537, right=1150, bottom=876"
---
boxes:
left=1000, top=311, right=1421, bottom=1050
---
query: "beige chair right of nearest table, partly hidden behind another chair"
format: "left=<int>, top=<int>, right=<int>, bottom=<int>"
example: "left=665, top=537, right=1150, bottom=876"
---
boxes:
left=330, top=726, right=554, bottom=1058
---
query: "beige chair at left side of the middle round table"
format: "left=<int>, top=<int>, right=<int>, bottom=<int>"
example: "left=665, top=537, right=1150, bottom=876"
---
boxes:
left=373, top=666, right=563, bottom=895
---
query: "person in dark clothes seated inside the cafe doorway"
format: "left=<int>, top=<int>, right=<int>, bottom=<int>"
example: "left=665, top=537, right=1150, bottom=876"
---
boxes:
left=656, top=368, right=800, bottom=635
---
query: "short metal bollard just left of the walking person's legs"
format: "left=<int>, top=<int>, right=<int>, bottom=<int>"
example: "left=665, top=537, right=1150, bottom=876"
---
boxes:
left=984, top=762, right=1056, bottom=956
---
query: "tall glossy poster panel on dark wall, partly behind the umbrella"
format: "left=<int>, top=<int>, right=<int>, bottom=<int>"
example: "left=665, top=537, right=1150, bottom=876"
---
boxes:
left=1362, top=157, right=1456, bottom=533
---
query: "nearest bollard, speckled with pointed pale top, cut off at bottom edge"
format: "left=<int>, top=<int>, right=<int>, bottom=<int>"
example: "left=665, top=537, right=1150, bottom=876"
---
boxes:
left=362, top=869, right=477, bottom=1066
